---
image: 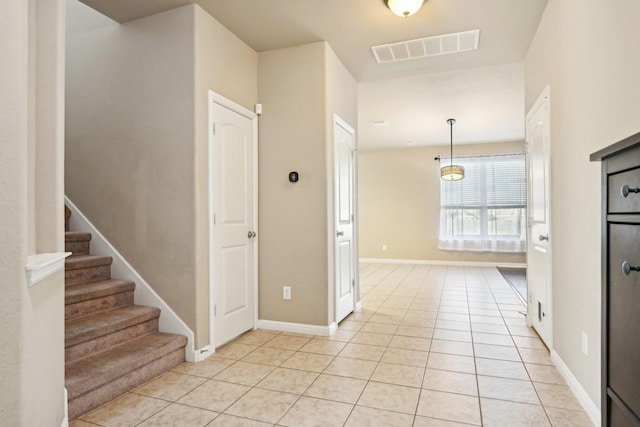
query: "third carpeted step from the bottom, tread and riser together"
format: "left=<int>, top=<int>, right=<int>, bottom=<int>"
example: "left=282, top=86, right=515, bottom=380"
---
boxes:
left=64, top=279, right=136, bottom=320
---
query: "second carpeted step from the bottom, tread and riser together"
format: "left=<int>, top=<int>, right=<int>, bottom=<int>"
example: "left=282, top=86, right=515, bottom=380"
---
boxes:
left=65, top=305, right=160, bottom=362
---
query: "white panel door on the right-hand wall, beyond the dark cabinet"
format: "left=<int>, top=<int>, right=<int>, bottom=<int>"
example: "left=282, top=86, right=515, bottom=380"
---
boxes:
left=526, top=87, right=553, bottom=349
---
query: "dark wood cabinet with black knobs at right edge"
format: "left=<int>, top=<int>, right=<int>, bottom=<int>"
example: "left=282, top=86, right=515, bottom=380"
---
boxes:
left=591, top=133, right=640, bottom=427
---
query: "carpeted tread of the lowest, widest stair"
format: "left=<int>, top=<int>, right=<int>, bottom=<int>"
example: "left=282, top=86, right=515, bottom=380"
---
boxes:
left=65, top=333, right=187, bottom=400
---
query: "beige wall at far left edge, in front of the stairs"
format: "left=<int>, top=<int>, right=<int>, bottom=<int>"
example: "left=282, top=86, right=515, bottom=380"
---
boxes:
left=0, top=0, right=66, bottom=427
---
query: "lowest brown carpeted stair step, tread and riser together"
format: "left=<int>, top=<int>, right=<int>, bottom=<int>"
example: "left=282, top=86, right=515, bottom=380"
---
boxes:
left=65, top=333, right=187, bottom=420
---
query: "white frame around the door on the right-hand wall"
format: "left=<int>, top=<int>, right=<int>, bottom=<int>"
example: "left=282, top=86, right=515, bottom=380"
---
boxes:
left=525, top=85, right=554, bottom=350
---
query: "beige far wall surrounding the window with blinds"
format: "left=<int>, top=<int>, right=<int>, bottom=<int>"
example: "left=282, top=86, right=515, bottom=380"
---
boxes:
left=358, top=142, right=525, bottom=263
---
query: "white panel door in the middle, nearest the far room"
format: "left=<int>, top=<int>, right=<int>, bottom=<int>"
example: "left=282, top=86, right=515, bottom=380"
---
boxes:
left=333, top=118, right=355, bottom=323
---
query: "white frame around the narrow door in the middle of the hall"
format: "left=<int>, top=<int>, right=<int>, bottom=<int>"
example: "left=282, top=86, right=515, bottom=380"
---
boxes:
left=329, top=113, right=359, bottom=325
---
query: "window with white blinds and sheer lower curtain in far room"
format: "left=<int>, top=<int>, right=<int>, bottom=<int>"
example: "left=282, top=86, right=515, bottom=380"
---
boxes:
left=438, top=154, right=527, bottom=252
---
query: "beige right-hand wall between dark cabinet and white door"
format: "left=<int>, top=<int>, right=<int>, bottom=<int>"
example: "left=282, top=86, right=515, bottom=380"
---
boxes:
left=525, top=0, right=640, bottom=412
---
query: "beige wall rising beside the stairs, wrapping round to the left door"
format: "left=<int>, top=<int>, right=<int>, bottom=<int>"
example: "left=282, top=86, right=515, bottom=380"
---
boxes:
left=65, top=1, right=257, bottom=347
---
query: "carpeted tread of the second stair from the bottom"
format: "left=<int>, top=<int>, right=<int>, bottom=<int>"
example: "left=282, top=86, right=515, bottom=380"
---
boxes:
left=64, top=305, right=160, bottom=348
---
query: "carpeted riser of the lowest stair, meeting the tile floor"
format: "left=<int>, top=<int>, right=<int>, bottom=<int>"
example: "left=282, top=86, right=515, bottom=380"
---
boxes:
left=69, top=348, right=184, bottom=421
